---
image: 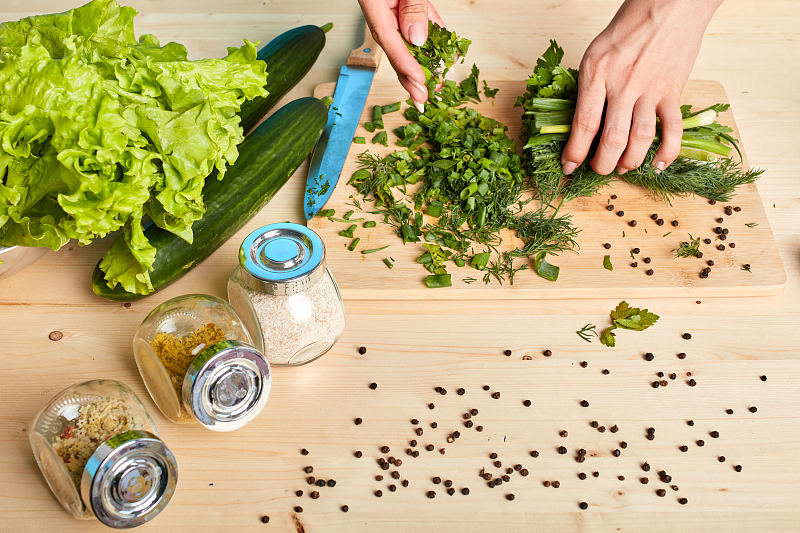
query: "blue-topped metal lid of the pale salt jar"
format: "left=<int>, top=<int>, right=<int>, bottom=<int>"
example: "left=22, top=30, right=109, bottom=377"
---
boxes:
left=239, top=222, right=325, bottom=296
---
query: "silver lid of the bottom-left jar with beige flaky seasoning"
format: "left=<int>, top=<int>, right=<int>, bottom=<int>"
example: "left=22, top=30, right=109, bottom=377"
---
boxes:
left=81, top=431, right=178, bottom=529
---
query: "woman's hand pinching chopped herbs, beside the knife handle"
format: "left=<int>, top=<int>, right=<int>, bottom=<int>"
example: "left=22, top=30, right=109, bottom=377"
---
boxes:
left=358, top=0, right=444, bottom=111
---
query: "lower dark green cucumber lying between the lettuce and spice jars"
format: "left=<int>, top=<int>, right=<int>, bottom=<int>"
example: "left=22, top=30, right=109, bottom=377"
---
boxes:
left=92, top=97, right=328, bottom=302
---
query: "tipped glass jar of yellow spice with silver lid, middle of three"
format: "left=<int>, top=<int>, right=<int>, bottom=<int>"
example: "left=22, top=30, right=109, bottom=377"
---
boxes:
left=133, top=294, right=272, bottom=431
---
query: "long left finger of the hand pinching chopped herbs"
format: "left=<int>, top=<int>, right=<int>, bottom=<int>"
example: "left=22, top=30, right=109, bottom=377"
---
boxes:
left=359, top=0, right=428, bottom=108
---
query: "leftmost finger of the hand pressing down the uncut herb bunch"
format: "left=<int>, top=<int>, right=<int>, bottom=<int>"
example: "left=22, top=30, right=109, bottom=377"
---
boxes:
left=561, top=70, right=606, bottom=174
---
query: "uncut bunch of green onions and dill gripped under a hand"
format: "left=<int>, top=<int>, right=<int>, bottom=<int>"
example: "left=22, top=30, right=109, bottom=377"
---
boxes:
left=517, top=41, right=763, bottom=203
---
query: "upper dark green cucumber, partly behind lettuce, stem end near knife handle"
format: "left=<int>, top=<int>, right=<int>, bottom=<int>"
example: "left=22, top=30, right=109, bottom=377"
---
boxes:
left=239, top=23, right=333, bottom=133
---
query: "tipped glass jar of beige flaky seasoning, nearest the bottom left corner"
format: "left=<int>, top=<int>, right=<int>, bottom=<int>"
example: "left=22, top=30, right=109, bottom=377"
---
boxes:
left=29, top=380, right=178, bottom=529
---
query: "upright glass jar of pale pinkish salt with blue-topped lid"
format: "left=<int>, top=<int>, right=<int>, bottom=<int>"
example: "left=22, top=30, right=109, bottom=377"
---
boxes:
left=228, top=223, right=345, bottom=365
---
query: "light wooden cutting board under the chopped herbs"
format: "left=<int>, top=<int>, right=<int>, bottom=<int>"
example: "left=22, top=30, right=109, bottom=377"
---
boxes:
left=308, top=81, right=786, bottom=299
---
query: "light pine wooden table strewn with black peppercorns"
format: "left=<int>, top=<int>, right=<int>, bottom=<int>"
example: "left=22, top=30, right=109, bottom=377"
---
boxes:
left=0, top=0, right=800, bottom=532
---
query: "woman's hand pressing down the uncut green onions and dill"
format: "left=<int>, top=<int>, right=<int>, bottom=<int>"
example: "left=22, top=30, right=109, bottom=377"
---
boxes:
left=561, top=0, right=722, bottom=174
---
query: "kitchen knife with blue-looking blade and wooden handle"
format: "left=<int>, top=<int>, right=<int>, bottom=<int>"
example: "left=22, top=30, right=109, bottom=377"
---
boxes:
left=303, top=24, right=382, bottom=220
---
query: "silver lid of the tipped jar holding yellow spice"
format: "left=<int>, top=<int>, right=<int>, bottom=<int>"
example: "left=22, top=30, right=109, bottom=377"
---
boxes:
left=181, top=341, right=272, bottom=431
